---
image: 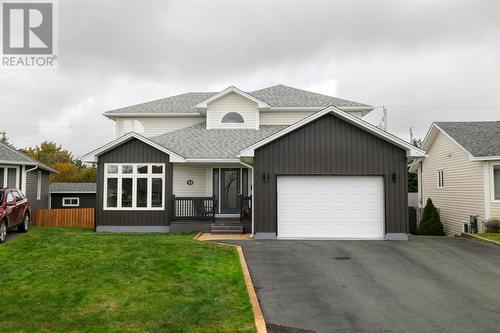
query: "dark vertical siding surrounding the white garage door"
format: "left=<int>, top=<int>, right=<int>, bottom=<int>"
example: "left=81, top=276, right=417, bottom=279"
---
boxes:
left=254, top=114, right=408, bottom=233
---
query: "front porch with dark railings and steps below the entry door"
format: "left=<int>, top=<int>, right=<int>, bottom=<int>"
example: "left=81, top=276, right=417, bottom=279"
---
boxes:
left=170, top=194, right=252, bottom=234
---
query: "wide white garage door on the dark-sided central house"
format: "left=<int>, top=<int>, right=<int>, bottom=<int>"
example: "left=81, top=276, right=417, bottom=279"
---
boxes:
left=278, top=176, right=384, bottom=239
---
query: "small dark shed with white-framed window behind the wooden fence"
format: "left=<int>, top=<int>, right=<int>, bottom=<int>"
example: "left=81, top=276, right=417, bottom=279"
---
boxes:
left=49, top=183, right=96, bottom=209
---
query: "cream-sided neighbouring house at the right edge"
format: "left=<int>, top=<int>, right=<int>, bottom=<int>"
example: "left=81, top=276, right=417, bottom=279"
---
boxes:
left=412, top=121, right=500, bottom=235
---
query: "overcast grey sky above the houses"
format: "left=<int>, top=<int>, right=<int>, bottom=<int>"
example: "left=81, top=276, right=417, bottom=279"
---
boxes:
left=0, top=0, right=500, bottom=156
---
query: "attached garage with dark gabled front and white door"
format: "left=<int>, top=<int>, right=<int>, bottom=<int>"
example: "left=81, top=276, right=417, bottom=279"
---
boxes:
left=240, top=107, right=425, bottom=240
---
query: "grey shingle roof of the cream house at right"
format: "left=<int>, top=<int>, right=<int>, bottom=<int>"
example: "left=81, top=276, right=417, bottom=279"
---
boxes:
left=436, top=121, right=500, bottom=157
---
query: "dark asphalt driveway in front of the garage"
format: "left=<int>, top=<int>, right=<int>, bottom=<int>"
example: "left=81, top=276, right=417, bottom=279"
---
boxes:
left=232, top=237, right=500, bottom=332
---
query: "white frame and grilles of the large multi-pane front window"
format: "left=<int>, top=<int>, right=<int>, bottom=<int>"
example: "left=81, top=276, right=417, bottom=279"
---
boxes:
left=103, top=163, right=165, bottom=211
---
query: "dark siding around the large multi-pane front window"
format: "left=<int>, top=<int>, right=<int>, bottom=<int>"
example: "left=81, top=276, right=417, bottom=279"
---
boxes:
left=96, top=139, right=172, bottom=226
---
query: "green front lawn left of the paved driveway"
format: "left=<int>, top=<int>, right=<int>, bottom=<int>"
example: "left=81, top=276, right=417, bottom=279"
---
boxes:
left=0, top=228, right=255, bottom=332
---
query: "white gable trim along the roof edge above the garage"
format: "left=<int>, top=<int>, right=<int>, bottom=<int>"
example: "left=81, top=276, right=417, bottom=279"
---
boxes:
left=240, top=106, right=425, bottom=158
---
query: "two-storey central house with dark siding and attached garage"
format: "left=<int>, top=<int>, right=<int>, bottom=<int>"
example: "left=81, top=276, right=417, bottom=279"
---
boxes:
left=84, top=85, right=424, bottom=239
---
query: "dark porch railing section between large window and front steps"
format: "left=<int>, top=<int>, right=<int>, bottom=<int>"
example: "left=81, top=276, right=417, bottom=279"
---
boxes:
left=171, top=195, right=217, bottom=221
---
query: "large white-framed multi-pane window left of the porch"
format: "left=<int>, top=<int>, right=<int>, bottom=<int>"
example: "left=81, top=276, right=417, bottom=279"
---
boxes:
left=103, top=163, right=165, bottom=210
